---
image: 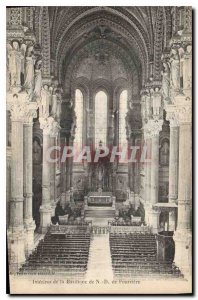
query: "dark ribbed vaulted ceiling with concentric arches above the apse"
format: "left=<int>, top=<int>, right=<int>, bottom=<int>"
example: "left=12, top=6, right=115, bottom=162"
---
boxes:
left=36, top=6, right=171, bottom=89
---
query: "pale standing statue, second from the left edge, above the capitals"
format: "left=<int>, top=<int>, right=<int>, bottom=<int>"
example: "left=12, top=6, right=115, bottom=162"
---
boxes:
left=23, top=46, right=34, bottom=95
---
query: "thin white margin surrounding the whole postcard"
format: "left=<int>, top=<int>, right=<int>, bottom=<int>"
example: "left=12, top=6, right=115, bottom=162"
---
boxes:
left=0, top=0, right=198, bottom=299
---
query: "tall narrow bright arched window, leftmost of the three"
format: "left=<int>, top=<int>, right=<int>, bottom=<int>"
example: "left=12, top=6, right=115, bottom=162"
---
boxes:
left=74, top=89, right=83, bottom=151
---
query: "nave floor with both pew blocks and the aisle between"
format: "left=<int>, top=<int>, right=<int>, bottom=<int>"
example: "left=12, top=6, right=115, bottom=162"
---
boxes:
left=18, top=225, right=184, bottom=282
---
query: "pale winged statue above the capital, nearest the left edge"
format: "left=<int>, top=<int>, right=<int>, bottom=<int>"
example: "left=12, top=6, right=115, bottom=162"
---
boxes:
left=7, top=40, right=24, bottom=87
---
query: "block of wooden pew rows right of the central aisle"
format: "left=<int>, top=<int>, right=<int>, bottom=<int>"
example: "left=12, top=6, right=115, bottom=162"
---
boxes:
left=109, top=233, right=183, bottom=279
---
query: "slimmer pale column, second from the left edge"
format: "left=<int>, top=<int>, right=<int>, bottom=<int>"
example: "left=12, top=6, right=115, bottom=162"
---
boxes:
left=23, top=103, right=36, bottom=255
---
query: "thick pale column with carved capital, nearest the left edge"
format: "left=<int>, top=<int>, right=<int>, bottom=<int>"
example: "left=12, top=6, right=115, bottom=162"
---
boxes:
left=8, top=99, right=25, bottom=273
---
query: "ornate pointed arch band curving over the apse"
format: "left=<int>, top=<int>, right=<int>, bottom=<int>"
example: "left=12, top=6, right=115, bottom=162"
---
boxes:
left=56, top=10, right=148, bottom=82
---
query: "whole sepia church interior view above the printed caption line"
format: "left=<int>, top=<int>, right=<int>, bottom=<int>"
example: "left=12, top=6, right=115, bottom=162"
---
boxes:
left=6, top=6, right=192, bottom=280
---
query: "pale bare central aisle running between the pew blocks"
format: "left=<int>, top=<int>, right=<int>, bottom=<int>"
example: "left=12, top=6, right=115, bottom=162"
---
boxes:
left=86, top=233, right=113, bottom=281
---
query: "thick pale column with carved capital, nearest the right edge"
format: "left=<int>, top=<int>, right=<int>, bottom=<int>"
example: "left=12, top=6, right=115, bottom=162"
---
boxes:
left=174, top=95, right=192, bottom=276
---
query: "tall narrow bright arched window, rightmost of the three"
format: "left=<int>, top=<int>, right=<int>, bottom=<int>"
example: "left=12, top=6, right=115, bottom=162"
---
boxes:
left=119, top=90, right=128, bottom=150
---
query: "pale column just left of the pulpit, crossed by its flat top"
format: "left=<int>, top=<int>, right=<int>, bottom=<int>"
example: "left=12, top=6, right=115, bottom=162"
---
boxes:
left=149, top=120, right=163, bottom=233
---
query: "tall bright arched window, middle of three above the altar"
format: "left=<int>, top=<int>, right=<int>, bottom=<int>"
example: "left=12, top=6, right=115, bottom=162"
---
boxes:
left=95, top=91, right=107, bottom=148
